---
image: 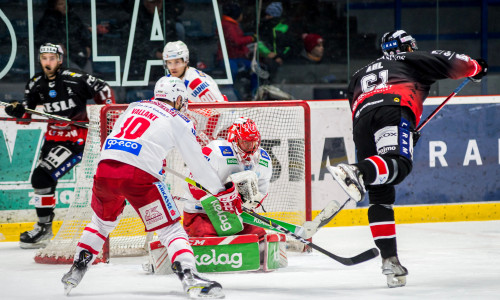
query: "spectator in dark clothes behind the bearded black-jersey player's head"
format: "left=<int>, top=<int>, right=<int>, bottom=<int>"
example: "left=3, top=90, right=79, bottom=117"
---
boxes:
left=35, top=0, right=93, bottom=73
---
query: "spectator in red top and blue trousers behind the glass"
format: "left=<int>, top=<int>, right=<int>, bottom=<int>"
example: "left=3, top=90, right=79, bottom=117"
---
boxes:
left=217, top=2, right=257, bottom=100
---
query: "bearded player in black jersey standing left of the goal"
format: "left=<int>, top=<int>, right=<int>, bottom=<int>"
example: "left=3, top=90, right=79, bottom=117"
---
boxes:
left=5, top=43, right=115, bottom=248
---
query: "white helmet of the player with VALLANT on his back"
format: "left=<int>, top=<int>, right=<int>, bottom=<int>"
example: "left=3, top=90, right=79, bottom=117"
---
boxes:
left=154, top=76, right=188, bottom=112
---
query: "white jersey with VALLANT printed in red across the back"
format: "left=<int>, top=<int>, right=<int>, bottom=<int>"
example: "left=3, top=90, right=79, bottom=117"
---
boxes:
left=100, top=100, right=224, bottom=194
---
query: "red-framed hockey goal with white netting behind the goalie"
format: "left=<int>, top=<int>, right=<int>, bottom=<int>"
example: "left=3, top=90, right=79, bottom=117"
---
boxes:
left=35, top=100, right=312, bottom=264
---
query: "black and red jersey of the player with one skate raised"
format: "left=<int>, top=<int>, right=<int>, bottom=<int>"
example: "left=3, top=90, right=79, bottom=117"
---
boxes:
left=347, top=50, right=481, bottom=124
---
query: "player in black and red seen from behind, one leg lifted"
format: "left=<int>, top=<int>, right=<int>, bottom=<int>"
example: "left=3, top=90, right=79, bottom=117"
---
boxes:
left=328, top=30, right=488, bottom=287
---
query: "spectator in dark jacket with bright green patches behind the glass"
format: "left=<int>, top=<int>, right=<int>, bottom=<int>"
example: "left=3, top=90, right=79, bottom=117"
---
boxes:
left=258, top=2, right=294, bottom=81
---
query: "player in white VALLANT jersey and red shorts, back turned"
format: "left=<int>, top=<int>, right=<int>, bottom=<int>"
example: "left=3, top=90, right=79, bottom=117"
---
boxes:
left=62, top=77, right=241, bottom=298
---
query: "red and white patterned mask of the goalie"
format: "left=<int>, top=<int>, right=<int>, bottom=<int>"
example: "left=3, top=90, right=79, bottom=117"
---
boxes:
left=227, top=117, right=260, bottom=161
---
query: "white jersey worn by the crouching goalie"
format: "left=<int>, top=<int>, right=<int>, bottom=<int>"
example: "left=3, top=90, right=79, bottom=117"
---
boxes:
left=184, top=140, right=273, bottom=213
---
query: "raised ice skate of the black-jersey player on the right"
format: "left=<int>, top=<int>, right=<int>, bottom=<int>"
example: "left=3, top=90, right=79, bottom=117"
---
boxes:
left=327, top=164, right=366, bottom=202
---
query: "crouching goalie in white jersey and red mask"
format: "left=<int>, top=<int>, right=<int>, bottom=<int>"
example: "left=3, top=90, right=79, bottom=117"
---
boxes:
left=183, top=117, right=272, bottom=245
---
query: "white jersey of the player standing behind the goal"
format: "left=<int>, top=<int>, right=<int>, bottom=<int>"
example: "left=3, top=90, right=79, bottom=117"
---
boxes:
left=167, top=67, right=227, bottom=102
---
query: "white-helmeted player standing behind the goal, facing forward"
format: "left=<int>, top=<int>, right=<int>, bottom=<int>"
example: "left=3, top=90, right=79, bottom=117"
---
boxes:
left=163, top=41, right=227, bottom=102
